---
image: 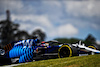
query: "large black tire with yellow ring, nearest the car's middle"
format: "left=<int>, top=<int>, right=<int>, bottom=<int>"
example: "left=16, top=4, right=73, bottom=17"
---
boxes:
left=58, top=44, right=79, bottom=58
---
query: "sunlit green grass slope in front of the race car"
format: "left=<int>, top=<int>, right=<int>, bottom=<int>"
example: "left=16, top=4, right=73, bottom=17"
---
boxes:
left=14, top=54, right=100, bottom=67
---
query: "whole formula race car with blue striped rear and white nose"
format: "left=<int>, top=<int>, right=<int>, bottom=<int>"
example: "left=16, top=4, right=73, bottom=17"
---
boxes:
left=1, top=39, right=100, bottom=63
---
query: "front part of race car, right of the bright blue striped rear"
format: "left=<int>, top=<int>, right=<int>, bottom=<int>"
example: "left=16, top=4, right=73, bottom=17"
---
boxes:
left=36, top=40, right=100, bottom=59
